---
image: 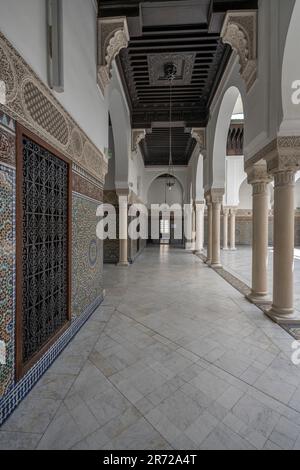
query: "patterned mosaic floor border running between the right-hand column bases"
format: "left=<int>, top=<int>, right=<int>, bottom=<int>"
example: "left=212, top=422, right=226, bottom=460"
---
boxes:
left=196, top=253, right=300, bottom=340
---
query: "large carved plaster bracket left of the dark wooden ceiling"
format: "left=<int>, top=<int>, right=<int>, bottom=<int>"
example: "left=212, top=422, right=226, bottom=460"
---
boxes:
left=98, top=16, right=129, bottom=93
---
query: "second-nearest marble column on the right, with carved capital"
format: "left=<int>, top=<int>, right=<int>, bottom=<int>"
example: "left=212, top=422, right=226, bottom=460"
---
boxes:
left=247, top=163, right=272, bottom=304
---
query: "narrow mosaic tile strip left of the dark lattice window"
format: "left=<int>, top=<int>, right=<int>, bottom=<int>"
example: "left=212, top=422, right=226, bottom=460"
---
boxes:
left=0, top=113, right=15, bottom=397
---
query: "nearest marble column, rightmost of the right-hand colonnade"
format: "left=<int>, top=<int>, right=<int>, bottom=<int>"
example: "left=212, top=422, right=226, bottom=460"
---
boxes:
left=267, top=169, right=300, bottom=323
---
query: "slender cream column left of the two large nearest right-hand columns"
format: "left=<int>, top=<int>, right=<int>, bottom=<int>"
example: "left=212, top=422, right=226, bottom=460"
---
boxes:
left=211, top=189, right=224, bottom=268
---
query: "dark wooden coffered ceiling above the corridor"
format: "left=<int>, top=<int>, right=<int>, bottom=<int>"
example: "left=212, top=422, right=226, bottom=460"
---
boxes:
left=99, top=0, right=257, bottom=165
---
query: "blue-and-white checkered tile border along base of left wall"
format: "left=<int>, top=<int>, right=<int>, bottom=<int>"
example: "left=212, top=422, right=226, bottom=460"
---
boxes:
left=0, top=296, right=103, bottom=426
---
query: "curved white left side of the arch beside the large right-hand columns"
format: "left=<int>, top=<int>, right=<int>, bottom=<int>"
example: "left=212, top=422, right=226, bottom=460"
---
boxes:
left=212, top=86, right=242, bottom=188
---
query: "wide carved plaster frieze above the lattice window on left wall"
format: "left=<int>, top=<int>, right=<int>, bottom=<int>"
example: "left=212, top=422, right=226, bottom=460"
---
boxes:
left=0, top=33, right=108, bottom=184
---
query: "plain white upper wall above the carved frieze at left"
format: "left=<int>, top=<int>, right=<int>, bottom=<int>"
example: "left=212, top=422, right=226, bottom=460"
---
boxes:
left=0, top=0, right=108, bottom=151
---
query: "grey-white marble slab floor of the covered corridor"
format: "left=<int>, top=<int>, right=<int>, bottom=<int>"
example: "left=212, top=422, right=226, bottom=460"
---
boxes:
left=0, top=246, right=300, bottom=450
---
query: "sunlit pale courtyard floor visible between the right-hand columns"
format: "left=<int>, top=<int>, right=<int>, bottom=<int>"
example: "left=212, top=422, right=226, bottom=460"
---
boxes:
left=221, top=246, right=300, bottom=312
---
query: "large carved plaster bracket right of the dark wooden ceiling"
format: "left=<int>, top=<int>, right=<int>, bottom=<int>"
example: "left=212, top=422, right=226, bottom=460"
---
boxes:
left=221, top=10, right=257, bottom=91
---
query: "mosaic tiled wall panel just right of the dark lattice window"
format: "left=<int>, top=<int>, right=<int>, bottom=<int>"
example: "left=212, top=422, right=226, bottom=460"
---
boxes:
left=72, top=194, right=103, bottom=318
